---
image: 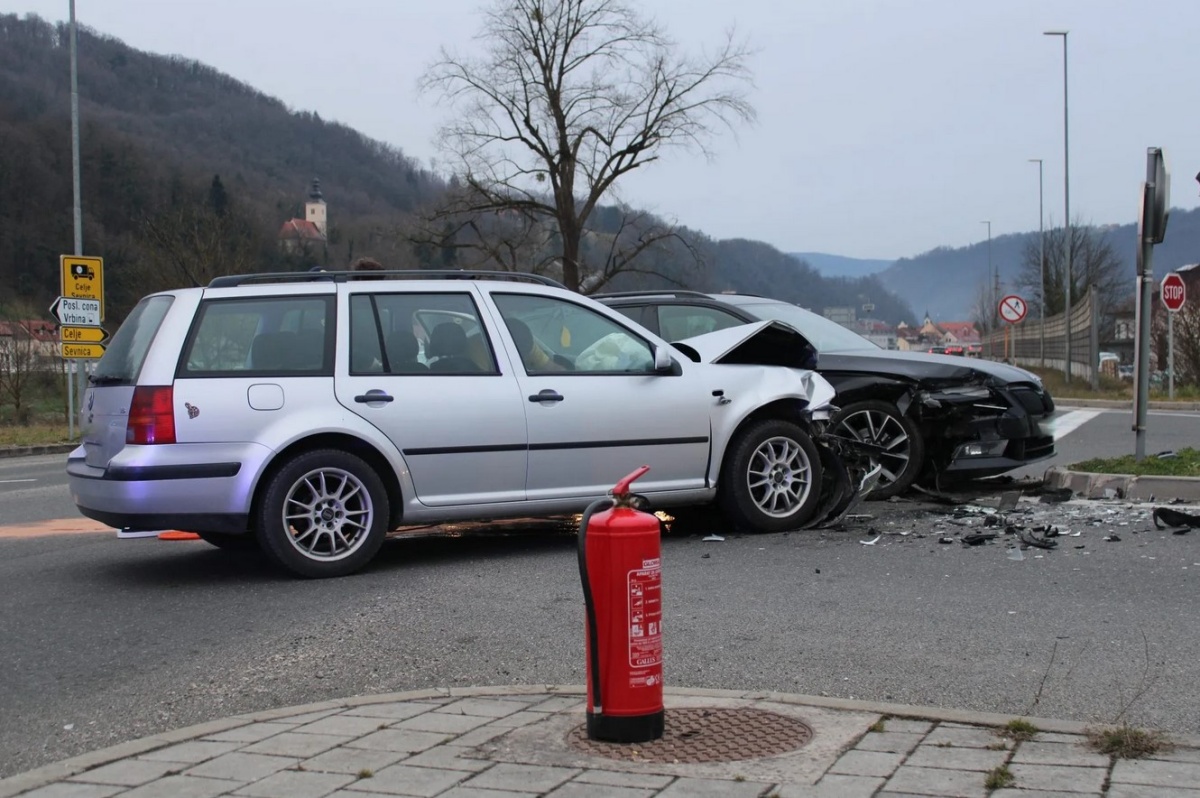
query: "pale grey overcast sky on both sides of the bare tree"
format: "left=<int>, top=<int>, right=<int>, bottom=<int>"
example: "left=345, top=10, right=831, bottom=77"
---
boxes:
left=9, top=0, right=1200, bottom=258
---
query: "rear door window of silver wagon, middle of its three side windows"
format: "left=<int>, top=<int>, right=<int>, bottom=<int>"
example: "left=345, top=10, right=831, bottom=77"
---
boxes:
left=350, top=293, right=499, bottom=376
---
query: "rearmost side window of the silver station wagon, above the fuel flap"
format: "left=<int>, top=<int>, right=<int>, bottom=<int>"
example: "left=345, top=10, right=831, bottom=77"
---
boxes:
left=180, top=296, right=334, bottom=377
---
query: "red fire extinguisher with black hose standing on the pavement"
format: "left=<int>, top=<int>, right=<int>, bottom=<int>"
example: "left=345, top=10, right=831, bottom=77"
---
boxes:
left=580, top=466, right=665, bottom=743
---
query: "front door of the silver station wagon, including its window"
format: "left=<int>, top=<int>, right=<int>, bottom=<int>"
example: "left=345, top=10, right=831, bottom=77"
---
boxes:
left=491, top=290, right=716, bottom=500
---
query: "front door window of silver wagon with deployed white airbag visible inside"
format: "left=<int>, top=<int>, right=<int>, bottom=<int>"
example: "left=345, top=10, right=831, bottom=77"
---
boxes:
left=492, top=293, right=654, bottom=374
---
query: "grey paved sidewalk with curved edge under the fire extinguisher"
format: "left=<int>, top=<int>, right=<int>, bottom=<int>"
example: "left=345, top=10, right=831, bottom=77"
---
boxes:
left=0, top=685, right=1200, bottom=798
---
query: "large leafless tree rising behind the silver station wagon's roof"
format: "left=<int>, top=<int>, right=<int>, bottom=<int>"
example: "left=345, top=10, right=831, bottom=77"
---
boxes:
left=420, top=0, right=755, bottom=290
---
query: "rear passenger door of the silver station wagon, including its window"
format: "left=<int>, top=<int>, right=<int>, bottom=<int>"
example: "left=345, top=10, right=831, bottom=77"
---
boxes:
left=337, top=286, right=528, bottom=506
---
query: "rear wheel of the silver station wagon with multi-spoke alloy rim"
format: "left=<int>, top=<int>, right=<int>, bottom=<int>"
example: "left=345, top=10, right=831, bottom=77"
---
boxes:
left=257, top=449, right=389, bottom=578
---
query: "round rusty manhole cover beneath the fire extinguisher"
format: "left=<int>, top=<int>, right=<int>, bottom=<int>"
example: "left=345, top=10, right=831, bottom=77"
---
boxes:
left=566, top=708, right=812, bottom=764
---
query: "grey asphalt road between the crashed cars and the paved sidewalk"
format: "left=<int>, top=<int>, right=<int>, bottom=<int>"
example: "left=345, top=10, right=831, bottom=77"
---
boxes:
left=0, top=405, right=1200, bottom=776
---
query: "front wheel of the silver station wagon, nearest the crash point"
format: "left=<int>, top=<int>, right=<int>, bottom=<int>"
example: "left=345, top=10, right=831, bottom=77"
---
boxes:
left=719, top=419, right=823, bottom=532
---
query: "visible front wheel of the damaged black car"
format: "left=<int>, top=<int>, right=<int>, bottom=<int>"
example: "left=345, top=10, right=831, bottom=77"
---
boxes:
left=832, top=401, right=925, bottom=499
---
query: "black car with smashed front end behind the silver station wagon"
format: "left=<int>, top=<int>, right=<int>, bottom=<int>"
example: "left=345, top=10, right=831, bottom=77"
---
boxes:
left=594, top=290, right=1055, bottom=499
